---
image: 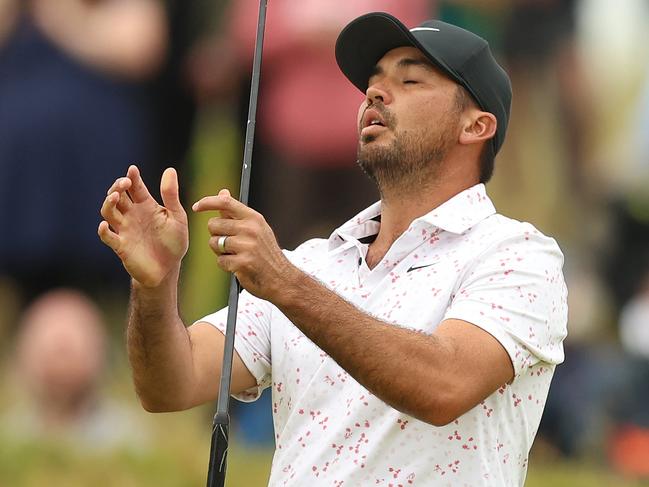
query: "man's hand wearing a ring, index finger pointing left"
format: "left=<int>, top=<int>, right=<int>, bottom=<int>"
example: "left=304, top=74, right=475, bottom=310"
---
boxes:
left=192, top=189, right=300, bottom=301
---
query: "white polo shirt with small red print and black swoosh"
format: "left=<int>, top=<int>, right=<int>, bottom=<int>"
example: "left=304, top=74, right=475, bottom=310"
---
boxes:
left=201, top=184, right=567, bottom=487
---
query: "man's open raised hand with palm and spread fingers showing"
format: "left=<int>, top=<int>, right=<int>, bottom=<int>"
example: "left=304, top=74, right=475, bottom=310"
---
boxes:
left=97, top=166, right=189, bottom=287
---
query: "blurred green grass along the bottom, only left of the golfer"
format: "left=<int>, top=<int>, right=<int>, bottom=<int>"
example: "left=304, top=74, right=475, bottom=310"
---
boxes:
left=0, top=402, right=271, bottom=487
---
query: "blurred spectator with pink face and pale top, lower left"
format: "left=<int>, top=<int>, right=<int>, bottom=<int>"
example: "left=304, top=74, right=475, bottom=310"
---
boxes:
left=0, top=290, right=144, bottom=451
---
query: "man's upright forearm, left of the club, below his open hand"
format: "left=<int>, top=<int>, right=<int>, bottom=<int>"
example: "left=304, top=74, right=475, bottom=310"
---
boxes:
left=127, top=271, right=193, bottom=412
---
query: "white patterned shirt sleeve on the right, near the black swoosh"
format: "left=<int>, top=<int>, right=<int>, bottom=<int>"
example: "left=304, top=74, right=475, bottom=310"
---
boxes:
left=444, top=226, right=568, bottom=377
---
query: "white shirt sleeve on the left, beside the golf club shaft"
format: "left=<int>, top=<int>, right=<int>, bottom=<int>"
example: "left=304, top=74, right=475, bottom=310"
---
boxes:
left=197, top=290, right=273, bottom=402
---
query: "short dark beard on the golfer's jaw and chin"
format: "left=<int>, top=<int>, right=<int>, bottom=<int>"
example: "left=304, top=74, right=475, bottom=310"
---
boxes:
left=357, top=108, right=459, bottom=195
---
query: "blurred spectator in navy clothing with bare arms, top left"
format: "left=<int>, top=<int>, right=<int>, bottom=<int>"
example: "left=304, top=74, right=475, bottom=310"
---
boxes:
left=0, top=0, right=167, bottom=336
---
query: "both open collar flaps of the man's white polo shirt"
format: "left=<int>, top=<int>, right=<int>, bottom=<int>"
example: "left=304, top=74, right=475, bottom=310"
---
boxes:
left=329, top=184, right=496, bottom=251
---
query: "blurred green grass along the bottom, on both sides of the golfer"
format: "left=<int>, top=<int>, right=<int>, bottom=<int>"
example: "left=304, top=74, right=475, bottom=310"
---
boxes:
left=0, top=420, right=647, bottom=487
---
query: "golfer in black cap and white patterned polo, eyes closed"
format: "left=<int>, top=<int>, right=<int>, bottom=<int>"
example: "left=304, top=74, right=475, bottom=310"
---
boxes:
left=99, top=13, right=566, bottom=486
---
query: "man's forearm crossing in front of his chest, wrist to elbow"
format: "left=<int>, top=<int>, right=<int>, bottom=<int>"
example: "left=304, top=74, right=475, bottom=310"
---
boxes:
left=275, top=275, right=454, bottom=424
